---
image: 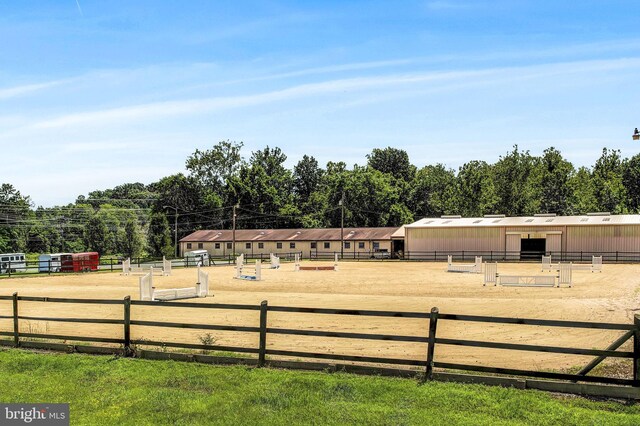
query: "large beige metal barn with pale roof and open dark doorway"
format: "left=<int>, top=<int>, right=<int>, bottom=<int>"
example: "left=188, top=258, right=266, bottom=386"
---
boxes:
left=404, top=213, right=640, bottom=261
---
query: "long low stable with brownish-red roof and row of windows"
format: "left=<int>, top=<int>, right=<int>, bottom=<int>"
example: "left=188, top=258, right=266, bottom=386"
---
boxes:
left=180, top=227, right=402, bottom=258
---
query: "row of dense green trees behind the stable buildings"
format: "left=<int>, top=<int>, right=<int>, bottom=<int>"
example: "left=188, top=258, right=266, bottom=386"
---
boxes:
left=0, top=141, right=640, bottom=257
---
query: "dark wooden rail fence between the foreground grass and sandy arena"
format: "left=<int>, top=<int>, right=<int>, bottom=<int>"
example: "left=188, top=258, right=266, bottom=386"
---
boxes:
left=0, top=293, right=640, bottom=387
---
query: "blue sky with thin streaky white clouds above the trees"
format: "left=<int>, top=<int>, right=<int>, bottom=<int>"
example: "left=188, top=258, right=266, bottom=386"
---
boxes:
left=0, top=0, right=640, bottom=206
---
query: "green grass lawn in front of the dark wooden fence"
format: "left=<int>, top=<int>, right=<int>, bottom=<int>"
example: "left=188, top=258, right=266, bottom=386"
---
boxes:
left=0, top=349, right=640, bottom=426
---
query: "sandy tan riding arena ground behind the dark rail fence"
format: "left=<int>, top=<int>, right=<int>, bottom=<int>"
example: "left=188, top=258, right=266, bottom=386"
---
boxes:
left=0, top=262, right=640, bottom=369
